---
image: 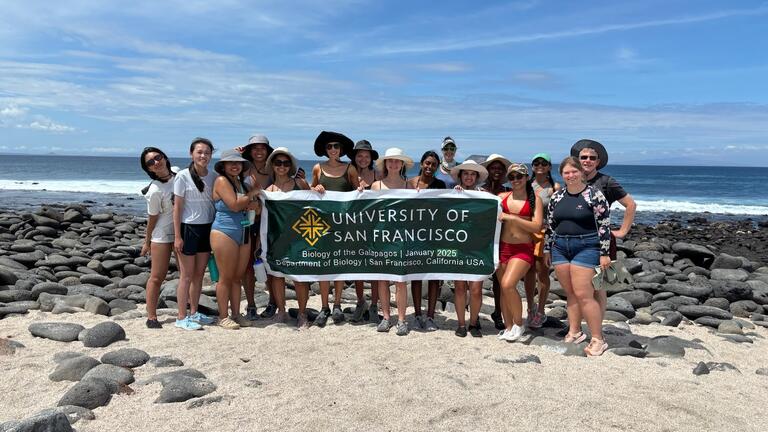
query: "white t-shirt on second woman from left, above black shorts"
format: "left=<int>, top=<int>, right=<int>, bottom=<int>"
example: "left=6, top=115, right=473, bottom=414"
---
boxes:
left=173, top=168, right=213, bottom=224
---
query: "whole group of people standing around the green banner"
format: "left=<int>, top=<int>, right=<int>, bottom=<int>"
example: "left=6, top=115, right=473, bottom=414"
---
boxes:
left=140, top=131, right=635, bottom=356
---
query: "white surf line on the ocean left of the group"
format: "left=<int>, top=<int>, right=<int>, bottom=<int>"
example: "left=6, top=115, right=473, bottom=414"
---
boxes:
left=0, top=179, right=149, bottom=195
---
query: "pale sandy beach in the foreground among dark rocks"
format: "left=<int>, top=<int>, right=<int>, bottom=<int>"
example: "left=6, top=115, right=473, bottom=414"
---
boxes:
left=0, top=290, right=768, bottom=431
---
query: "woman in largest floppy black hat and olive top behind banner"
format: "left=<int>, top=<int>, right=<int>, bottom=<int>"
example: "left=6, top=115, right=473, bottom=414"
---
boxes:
left=312, top=131, right=360, bottom=327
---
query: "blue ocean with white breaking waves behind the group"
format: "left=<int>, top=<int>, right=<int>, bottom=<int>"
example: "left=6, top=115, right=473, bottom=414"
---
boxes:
left=0, top=155, right=768, bottom=224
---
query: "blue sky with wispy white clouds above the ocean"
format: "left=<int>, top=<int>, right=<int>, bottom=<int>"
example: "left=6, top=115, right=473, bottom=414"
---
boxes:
left=0, top=0, right=768, bottom=166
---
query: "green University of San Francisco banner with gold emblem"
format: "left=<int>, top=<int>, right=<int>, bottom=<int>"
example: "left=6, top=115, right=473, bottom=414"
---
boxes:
left=261, top=190, right=501, bottom=282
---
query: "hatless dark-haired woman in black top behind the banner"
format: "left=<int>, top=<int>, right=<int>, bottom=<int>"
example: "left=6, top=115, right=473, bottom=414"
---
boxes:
left=408, top=150, right=446, bottom=331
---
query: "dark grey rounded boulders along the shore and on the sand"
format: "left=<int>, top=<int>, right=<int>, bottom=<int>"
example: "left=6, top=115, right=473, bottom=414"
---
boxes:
left=0, top=205, right=768, bottom=430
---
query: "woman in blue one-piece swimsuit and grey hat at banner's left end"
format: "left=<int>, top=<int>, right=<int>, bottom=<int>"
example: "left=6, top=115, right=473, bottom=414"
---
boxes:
left=211, top=150, right=261, bottom=330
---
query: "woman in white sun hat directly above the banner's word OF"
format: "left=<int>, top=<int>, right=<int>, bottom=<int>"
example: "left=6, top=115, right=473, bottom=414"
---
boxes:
left=451, top=160, right=488, bottom=337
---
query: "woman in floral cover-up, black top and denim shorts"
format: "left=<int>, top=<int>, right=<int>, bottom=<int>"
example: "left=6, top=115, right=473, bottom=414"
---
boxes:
left=544, top=156, right=611, bottom=356
